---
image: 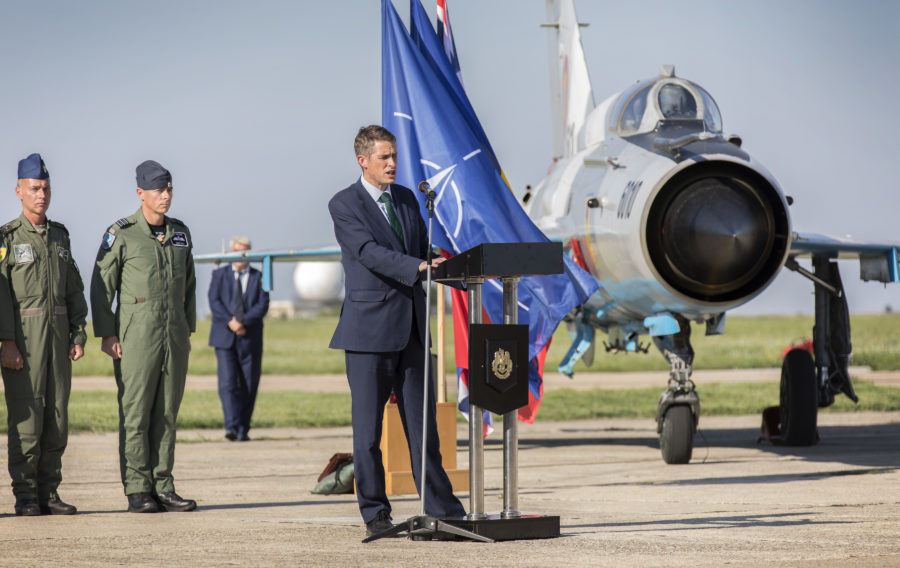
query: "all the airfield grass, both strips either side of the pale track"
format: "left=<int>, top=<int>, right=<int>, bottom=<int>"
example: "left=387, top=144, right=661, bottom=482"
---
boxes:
left=0, top=311, right=900, bottom=432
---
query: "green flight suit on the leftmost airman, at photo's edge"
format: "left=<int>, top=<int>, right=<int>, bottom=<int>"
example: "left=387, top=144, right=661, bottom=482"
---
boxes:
left=0, top=214, right=87, bottom=500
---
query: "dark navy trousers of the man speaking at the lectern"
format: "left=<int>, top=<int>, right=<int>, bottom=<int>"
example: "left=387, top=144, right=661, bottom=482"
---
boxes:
left=345, top=333, right=465, bottom=523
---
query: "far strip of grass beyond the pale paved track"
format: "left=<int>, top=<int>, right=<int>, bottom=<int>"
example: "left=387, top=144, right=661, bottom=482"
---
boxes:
left=72, top=310, right=900, bottom=376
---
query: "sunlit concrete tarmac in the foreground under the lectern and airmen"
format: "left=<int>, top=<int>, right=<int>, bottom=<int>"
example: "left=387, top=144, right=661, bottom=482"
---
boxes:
left=0, top=406, right=900, bottom=568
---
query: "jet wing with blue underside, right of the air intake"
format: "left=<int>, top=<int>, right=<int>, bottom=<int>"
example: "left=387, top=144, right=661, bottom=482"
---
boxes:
left=790, top=233, right=900, bottom=283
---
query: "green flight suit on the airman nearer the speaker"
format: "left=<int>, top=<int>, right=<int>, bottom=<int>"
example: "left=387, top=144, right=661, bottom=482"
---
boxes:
left=91, top=209, right=197, bottom=495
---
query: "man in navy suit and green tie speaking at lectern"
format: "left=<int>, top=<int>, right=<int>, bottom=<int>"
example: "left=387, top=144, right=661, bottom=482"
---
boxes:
left=328, top=125, right=465, bottom=536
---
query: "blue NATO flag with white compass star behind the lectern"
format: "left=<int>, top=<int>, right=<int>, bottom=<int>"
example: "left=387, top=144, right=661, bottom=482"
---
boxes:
left=382, top=0, right=599, bottom=418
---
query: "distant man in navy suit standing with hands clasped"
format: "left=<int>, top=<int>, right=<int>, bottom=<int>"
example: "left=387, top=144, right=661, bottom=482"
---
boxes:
left=209, top=237, right=269, bottom=442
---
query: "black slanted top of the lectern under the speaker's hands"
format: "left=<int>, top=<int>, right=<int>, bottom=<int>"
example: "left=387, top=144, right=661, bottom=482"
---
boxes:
left=432, top=242, right=563, bottom=282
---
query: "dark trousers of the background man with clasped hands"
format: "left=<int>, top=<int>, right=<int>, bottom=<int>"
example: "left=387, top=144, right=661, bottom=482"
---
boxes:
left=216, top=338, right=262, bottom=434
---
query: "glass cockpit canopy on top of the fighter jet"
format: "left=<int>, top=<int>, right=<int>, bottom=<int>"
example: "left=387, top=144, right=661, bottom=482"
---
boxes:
left=608, top=74, right=722, bottom=136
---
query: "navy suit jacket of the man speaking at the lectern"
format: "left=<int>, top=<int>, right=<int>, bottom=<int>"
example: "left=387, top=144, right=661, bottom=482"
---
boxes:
left=328, top=181, right=428, bottom=352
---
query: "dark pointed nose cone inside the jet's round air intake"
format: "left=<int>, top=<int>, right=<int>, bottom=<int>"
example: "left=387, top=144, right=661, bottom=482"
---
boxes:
left=661, top=178, right=775, bottom=291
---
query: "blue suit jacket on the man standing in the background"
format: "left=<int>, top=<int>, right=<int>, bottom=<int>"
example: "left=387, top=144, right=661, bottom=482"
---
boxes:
left=209, top=264, right=269, bottom=349
